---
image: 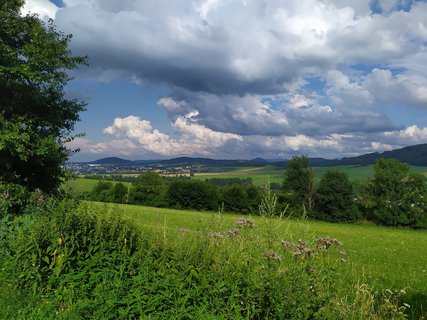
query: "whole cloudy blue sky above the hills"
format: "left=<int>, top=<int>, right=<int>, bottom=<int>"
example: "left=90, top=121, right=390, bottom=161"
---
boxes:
left=22, top=0, right=427, bottom=161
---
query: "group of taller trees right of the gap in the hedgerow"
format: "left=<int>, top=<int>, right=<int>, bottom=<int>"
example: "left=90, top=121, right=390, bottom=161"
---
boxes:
left=282, top=157, right=427, bottom=228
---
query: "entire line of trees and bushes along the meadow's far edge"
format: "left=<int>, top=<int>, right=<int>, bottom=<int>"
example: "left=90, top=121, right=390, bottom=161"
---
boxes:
left=84, top=157, right=427, bottom=228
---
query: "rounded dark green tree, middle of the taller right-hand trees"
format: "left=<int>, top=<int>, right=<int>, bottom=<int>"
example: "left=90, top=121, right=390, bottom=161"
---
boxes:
left=314, top=171, right=361, bottom=222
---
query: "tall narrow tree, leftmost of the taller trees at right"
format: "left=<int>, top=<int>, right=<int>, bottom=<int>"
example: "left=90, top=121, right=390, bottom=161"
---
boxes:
left=283, top=156, right=314, bottom=211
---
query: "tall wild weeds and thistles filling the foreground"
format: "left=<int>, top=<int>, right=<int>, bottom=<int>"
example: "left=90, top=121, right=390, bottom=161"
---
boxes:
left=0, top=199, right=414, bottom=319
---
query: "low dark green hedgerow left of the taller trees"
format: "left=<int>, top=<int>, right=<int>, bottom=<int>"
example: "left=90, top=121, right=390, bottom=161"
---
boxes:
left=86, top=171, right=261, bottom=213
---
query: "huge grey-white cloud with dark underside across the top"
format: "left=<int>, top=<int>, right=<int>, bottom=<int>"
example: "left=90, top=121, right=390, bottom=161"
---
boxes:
left=51, top=0, right=427, bottom=94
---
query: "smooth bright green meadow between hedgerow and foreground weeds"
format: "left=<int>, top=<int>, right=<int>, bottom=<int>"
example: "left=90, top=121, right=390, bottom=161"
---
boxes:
left=89, top=203, right=427, bottom=316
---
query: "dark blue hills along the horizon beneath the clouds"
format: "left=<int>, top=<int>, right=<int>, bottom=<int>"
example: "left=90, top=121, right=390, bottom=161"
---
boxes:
left=86, top=143, right=427, bottom=167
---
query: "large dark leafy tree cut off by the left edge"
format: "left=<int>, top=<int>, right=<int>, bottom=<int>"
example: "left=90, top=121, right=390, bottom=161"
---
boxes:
left=0, top=0, right=86, bottom=192
